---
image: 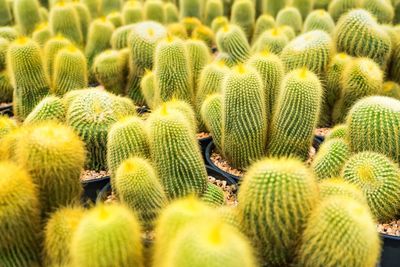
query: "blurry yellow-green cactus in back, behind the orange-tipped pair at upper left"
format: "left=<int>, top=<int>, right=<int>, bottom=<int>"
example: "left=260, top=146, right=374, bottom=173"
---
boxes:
left=49, top=2, right=83, bottom=45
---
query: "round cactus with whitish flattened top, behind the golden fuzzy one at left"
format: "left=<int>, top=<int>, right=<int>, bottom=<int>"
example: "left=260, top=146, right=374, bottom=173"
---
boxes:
left=67, top=90, right=118, bottom=170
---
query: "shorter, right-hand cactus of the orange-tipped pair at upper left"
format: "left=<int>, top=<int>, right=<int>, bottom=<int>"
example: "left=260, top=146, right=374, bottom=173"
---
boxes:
left=52, top=45, right=88, bottom=96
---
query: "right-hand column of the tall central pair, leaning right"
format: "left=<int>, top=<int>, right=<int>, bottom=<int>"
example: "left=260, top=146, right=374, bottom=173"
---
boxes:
left=267, top=68, right=322, bottom=160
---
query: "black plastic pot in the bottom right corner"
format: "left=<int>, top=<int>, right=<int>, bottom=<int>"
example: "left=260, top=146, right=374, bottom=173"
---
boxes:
left=379, top=234, right=400, bottom=267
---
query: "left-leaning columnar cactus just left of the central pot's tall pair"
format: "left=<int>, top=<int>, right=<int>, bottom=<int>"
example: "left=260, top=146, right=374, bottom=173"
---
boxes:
left=149, top=105, right=207, bottom=199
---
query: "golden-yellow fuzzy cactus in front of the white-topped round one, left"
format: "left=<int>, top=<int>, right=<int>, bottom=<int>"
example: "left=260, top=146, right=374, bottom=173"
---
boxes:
left=15, top=122, right=85, bottom=219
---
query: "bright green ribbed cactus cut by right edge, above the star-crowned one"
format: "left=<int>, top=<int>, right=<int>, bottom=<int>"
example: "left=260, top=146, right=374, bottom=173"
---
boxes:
left=347, top=96, right=400, bottom=163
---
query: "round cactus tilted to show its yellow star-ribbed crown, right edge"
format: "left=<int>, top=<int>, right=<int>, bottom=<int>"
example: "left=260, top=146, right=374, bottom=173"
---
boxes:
left=342, top=151, right=400, bottom=222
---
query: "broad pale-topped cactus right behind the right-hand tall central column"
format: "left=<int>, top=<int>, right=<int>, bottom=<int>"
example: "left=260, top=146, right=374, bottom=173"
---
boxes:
left=281, top=30, right=334, bottom=76
